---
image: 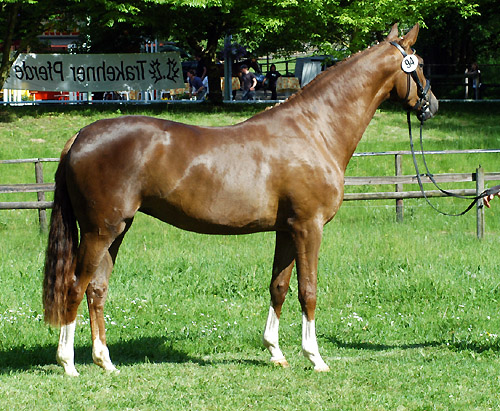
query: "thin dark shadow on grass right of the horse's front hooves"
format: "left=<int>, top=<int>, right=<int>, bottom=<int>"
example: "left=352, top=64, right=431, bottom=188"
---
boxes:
left=325, top=337, right=500, bottom=353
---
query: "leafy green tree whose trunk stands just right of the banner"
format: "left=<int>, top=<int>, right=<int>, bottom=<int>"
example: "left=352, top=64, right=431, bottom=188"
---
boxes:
left=78, top=0, right=475, bottom=102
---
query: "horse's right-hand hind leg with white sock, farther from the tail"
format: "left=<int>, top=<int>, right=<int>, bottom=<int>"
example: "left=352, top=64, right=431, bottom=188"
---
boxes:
left=87, top=220, right=132, bottom=372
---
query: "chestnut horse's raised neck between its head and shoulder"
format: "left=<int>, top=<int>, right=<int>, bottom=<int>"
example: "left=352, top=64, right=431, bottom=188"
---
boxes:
left=278, top=44, right=391, bottom=169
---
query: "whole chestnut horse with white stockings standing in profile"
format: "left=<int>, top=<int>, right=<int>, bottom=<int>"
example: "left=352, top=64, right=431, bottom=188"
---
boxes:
left=43, top=25, right=438, bottom=375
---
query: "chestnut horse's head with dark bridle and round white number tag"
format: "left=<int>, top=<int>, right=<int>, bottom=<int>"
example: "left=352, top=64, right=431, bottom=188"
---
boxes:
left=386, top=24, right=439, bottom=120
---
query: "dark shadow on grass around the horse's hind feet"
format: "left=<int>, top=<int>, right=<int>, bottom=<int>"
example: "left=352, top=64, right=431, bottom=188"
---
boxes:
left=0, top=337, right=268, bottom=374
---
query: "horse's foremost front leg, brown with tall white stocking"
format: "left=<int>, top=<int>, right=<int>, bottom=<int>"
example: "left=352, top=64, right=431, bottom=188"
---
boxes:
left=293, top=221, right=330, bottom=371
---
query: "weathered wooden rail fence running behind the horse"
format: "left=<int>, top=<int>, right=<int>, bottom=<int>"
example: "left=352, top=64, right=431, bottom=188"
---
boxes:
left=0, top=149, right=500, bottom=238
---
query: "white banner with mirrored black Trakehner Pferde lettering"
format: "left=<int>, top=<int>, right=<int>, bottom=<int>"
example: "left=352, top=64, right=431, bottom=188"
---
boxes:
left=3, top=53, right=184, bottom=91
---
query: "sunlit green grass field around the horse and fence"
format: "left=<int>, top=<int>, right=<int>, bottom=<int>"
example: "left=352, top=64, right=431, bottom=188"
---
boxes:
left=0, top=104, right=500, bottom=410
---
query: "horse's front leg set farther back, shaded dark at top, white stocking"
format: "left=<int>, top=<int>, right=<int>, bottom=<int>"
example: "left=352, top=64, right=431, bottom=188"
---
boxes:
left=263, top=232, right=295, bottom=367
